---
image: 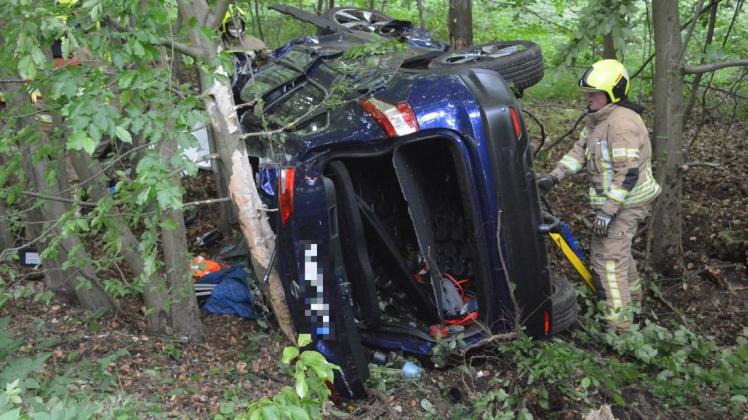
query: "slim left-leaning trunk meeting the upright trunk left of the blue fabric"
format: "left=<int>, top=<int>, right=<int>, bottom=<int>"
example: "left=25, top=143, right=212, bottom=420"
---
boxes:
left=70, top=152, right=172, bottom=335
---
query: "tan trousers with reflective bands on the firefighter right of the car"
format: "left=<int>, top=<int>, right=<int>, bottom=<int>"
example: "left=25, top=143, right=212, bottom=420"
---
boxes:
left=590, top=202, right=652, bottom=329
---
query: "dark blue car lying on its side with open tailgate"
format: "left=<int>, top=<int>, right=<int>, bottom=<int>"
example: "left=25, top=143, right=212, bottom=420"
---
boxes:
left=235, top=6, right=576, bottom=398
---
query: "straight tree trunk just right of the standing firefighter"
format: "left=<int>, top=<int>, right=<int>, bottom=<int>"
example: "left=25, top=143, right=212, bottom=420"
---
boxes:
left=652, top=0, right=683, bottom=276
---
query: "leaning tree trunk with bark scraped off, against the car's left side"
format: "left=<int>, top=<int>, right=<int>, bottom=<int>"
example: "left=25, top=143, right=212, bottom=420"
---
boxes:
left=179, top=0, right=296, bottom=342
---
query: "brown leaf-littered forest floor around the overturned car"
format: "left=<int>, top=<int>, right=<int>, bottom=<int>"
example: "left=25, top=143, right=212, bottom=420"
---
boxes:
left=0, top=101, right=748, bottom=418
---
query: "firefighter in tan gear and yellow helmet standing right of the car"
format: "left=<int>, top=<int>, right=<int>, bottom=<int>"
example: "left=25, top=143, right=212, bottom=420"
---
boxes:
left=538, top=60, right=661, bottom=330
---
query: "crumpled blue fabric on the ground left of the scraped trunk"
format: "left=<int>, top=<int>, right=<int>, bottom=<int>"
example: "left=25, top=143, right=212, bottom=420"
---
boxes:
left=197, top=264, right=257, bottom=319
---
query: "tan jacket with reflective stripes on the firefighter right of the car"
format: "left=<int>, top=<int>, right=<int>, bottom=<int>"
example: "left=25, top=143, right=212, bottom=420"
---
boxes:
left=551, top=104, right=661, bottom=215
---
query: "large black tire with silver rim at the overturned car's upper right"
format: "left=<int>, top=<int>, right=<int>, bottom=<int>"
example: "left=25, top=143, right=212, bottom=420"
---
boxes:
left=429, top=41, right=545, bottom=89
